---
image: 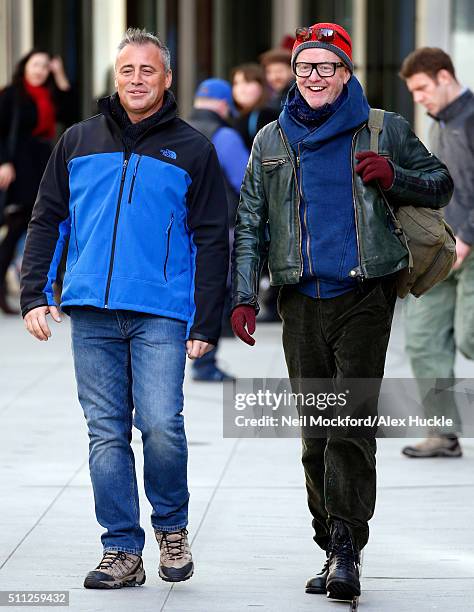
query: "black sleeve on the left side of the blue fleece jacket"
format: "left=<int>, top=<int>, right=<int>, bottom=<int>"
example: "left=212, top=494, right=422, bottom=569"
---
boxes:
left=21, top=133, right=70, bottom=316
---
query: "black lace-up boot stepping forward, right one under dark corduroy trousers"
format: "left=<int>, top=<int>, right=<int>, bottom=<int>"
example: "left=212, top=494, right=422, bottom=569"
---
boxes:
left=326, top=521, right=360, bottom=600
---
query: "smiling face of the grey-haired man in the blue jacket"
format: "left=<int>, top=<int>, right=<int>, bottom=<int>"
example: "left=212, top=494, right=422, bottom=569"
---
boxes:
left=115, top=43, right=172, bottom=123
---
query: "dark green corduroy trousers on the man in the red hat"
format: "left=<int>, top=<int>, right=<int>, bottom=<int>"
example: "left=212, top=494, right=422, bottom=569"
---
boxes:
left=279, top=277, right=396, bottom=550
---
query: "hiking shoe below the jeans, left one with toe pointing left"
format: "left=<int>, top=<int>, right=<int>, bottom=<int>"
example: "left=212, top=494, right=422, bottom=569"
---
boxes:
left=84, top=550, right=146, bottom=589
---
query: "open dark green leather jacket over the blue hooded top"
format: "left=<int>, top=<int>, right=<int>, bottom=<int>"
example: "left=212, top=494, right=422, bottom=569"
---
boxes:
left=232, top=112, right=453, bottom=310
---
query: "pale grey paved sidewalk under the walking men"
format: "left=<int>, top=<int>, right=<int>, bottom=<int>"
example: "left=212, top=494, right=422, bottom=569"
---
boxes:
left=0, top=306, right=474, bottom=612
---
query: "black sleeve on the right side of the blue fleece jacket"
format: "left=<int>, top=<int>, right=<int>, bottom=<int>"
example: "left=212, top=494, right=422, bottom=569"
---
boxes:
left=188, top=143, right=229, bottom=344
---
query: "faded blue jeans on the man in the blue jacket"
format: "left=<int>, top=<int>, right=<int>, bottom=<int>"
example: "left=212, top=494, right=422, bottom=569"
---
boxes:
left=71, top=308, right=189, bottom=555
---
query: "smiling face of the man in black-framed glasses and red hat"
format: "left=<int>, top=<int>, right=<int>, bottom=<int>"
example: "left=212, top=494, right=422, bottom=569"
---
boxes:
left=296, top=48, right=351, bottom=108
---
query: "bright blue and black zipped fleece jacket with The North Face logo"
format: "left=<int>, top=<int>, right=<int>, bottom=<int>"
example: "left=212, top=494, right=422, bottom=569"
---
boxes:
left=21, top=92, right=229, bottom=344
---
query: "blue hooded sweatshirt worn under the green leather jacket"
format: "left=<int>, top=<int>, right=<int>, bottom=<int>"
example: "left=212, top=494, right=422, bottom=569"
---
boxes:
left=279, top=76, right=369, bottom=298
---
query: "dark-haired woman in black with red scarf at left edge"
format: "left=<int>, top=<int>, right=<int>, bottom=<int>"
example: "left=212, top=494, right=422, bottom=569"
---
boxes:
left=0, top=50, right=71, bottom=314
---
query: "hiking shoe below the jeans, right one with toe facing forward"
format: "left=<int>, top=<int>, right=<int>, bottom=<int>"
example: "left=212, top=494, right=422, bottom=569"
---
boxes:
left=155, top=529, right=194, bottom=582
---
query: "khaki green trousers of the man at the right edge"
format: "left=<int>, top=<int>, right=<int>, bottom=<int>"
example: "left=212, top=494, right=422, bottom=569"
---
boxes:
left=405, top=253, right=474, bottom=434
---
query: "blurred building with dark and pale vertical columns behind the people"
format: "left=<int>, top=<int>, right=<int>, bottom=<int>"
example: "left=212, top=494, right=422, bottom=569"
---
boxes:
left=0, top=0, right=474, bottom=136
